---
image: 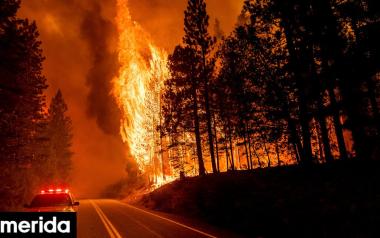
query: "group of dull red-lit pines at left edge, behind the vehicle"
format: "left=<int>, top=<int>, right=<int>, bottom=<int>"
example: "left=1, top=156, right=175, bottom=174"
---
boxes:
left=0, top=0, right=72, bottom=211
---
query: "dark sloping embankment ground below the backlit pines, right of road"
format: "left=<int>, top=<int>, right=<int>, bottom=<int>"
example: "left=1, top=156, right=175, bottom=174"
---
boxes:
left=139, top=161, right=380, bottom=238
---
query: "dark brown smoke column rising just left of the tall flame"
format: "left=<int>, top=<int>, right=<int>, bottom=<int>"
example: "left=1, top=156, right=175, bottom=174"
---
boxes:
left=81, top=1, right=120, bottom=135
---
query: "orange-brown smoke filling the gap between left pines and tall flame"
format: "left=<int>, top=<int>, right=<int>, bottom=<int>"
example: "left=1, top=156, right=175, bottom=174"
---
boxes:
left=20, top=0, right=127, bottom=197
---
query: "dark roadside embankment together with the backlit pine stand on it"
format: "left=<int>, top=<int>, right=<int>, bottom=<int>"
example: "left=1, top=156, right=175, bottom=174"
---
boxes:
left=137, top=0, right=380, bottom=237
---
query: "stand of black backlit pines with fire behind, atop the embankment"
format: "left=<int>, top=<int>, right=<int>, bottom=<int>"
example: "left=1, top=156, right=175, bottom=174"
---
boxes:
left=158, top=0, right=380, bottom=176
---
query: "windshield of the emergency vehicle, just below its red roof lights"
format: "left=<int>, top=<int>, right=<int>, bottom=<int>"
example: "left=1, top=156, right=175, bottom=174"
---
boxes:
left=30, top=193, right=72, bottom=207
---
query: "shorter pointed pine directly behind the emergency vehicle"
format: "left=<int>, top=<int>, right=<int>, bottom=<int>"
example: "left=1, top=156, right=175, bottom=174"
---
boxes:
left=48, top=90, right=73, bottom=183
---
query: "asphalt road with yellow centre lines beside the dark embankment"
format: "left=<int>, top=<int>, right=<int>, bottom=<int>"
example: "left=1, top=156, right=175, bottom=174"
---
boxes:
left=78, top=199, right=243, bottom=238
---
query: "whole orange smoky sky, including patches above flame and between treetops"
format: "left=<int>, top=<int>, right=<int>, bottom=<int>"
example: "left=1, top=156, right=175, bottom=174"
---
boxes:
left=20, top=0, right=243, bottom=196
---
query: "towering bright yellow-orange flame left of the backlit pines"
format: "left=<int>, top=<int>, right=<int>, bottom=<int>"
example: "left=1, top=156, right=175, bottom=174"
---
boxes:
left=113, top=0, right=169, bottom=171
